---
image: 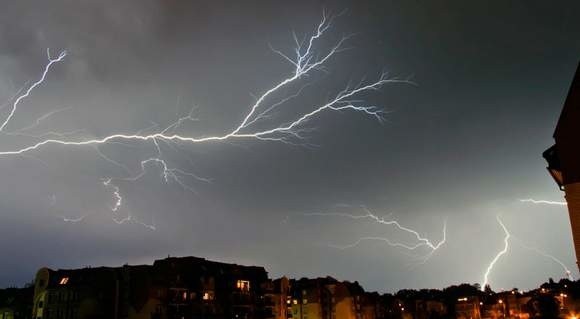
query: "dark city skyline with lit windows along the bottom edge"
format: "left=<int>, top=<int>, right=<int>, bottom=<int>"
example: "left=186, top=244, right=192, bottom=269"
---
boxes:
left=7, top=256, right=580, bottom=319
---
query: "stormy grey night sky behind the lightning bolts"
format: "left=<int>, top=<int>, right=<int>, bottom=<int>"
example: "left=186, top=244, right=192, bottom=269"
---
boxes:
left=0, top=0, right=580, bottom=291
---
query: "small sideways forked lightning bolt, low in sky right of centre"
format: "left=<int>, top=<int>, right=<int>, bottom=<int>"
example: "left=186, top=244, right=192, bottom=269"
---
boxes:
left=304, top=207, right=447, bottom=263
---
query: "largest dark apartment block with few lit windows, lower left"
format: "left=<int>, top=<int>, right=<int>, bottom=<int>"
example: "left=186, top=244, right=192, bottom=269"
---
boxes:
left=33, top=257, right=274, bottom=319
